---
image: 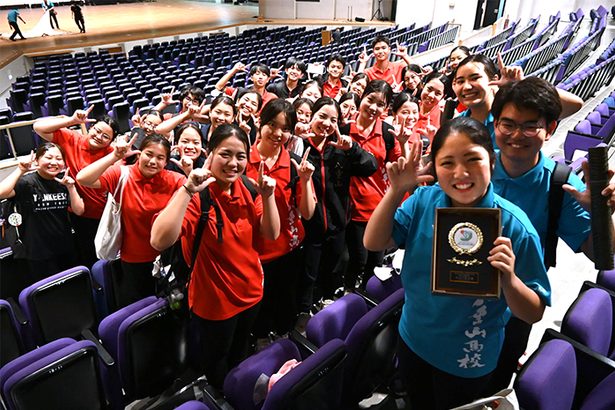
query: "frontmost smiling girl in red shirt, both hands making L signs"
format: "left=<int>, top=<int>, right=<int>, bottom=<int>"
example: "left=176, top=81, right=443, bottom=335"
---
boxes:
left=151, top=125, right=280, bottom=388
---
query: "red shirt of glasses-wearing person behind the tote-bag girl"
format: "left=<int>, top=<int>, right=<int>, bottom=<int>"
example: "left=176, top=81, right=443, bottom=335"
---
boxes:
left=53, top=128, right=113, bottom=219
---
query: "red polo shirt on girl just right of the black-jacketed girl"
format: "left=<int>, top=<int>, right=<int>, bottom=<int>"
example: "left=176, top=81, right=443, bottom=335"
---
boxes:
left=349, top=118, right=401, bottom=222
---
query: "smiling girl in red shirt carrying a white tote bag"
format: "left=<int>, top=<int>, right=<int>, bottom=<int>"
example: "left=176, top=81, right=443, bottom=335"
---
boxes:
left=77, top=134, right=186, bottom=306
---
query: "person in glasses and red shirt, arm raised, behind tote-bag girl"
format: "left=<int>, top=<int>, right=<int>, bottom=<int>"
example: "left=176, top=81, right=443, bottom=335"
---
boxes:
left=34, top=105, right=119, bottom=268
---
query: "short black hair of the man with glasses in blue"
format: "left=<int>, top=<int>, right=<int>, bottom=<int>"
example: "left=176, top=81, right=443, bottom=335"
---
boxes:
left=491, top=77, right=562, bottom=124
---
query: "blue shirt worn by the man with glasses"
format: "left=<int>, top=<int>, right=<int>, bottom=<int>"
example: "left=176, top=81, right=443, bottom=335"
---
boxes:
left=491, top=152, right=591, bottom=252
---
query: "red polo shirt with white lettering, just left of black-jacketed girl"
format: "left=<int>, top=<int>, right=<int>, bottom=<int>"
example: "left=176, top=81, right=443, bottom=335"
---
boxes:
left=246, top=144, right=305, bottom=263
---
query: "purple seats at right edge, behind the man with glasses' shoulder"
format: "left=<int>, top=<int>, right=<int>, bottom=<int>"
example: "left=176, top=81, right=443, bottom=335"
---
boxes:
left=557, top=91, right=615, bottom=172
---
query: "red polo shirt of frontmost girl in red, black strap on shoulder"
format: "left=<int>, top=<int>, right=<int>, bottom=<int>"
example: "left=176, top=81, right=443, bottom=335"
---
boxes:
left=181, top=180, right=264, bottom=320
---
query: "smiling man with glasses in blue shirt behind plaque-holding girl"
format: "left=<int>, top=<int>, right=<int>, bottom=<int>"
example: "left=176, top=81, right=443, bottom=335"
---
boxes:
left=486, top=77, right=615, bottom=394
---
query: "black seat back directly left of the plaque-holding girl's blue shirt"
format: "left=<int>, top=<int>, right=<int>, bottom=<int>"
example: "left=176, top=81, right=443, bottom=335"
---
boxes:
left=342, top=289, right=404, bottom=405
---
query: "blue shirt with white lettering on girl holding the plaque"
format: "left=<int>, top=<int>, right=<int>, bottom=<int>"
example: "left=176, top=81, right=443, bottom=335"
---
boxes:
left=393, top=184, right=551, bottom=378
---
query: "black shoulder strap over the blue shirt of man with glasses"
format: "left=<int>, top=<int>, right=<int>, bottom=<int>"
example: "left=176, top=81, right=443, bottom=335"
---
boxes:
left=544, top=162, right=572, bottom=269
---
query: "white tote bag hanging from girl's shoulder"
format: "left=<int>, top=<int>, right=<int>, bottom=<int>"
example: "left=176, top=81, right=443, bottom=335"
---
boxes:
left=94, top=166, right=130, bottom=260
